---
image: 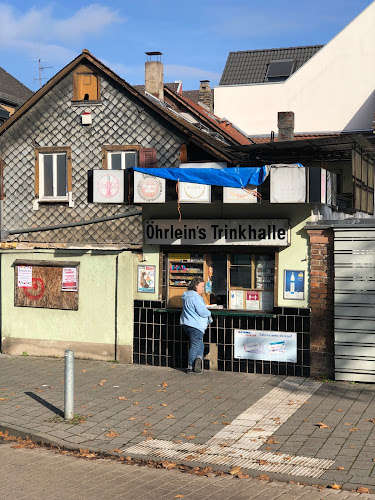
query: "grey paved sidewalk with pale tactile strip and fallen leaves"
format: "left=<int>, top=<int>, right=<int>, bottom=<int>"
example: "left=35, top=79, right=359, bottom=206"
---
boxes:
left=0, top=355, right=375, bottom=492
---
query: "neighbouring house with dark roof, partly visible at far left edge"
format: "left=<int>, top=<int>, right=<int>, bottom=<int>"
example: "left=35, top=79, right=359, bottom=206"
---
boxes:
left=0, top=67, right=33, bottom=124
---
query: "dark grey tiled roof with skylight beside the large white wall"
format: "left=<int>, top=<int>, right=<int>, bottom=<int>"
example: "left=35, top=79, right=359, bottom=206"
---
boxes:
left=219, top=45, right=323, bottom=85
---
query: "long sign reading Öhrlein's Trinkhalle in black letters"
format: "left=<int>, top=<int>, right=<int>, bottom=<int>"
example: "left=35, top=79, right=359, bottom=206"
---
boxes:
left=143, top=219, right=290, bottom=246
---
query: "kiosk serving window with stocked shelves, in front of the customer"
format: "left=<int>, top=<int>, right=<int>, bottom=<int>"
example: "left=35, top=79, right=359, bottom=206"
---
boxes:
left=166, top=249, right=277, bottom=311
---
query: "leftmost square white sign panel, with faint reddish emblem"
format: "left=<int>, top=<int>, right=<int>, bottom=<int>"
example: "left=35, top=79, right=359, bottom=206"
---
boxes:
left=93, top=169, right=125, bottom=203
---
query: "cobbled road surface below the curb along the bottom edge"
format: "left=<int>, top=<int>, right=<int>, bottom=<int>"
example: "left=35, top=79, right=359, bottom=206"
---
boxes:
left=0, top=440, right=375, bottom=500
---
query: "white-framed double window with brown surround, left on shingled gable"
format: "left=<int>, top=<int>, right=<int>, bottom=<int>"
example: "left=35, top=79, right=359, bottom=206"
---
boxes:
left=35, top=148, right=71, bottom=202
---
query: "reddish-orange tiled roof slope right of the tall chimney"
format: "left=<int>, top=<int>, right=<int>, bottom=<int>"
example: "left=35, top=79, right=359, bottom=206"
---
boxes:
left=164, top=88, right=251, bottom=144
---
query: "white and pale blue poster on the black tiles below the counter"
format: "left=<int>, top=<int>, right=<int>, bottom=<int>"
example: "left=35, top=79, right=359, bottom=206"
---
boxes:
left=234, top=330, right=297, bottom=363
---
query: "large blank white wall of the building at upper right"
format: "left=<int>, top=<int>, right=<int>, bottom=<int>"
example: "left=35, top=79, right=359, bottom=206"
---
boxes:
left=214, top=1, right=375, bottom=135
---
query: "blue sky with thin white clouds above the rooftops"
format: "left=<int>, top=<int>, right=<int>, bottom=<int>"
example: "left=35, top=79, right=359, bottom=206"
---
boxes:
left=0, top=0, right=372, bottom=90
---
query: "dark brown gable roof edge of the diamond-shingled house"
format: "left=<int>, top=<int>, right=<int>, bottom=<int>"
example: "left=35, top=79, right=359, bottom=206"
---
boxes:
left=0, top=49, right=235, bottom=162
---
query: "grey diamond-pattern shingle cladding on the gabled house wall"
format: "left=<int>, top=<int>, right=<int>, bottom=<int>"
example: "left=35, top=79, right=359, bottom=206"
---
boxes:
left=0, top=74, right=184, bottom=245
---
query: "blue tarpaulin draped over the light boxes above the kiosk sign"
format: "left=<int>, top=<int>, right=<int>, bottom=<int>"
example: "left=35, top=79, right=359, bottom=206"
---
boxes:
left=133, top=166, right=268, bottom=188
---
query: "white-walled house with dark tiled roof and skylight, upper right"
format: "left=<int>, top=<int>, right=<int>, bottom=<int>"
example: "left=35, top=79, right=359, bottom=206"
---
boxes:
left=214, top=2, right=375, bottom=137
